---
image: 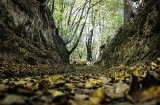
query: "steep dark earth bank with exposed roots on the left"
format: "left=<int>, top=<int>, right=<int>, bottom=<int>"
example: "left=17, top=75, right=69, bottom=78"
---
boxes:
left=0, top=0, right=69, bottom=65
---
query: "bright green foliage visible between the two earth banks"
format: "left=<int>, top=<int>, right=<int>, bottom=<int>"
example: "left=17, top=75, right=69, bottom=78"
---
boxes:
left=49, top=0, right=124, bottom=59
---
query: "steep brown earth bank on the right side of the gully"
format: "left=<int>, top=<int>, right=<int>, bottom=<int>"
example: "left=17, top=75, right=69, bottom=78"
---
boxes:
left=97, top=0, right=160, bottom=67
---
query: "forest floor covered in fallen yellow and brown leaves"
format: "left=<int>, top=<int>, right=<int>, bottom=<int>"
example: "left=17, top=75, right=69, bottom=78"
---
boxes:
left=0, top=58, right=160, bottom=105
